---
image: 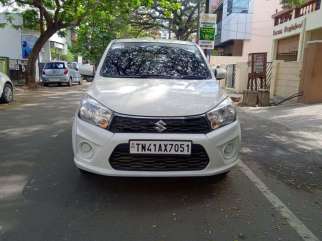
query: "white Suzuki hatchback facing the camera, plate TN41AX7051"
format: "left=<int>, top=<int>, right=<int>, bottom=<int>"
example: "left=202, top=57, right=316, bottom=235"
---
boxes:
left=72, top=39, right=240, bottom=177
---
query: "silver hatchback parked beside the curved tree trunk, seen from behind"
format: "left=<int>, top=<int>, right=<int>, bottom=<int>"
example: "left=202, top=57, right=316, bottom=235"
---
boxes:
left=42, top=61, right=81, bottom=86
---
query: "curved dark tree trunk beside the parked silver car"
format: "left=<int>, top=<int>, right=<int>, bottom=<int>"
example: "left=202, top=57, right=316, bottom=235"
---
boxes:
left=25, top=26, right=60, bottom=88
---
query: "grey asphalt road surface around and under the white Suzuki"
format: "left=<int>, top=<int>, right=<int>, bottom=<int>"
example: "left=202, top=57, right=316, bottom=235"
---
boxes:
left=0, top=86, right=322, bottom=241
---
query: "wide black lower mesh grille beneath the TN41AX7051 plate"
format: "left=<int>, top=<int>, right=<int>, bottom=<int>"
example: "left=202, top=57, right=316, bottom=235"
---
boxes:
left=109, top=144, right=209, bottom=171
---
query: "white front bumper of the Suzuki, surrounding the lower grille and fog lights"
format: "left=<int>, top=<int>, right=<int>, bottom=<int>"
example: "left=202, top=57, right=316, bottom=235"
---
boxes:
left=72, top=115, right=240, bottom=177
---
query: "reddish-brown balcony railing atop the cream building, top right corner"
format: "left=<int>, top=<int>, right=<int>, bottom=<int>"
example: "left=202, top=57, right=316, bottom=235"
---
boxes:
left=273, top=0, right=321, bottom=26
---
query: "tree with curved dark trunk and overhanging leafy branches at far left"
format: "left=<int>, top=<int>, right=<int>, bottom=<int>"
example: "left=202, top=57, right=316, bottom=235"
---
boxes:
left=0, top=0, right=175, bottom=86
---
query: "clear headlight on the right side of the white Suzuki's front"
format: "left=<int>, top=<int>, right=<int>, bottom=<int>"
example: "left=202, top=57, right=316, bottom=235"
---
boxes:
left=207, top=98, right=236, bottom=129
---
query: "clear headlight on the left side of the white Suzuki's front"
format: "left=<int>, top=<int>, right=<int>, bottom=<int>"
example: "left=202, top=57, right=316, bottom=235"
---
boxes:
left=78, top=96, right=112, bottom=129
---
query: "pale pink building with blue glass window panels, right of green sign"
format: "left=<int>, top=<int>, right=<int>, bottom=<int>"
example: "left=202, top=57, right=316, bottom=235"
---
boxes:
left=212, top=0, right=281, bottom=64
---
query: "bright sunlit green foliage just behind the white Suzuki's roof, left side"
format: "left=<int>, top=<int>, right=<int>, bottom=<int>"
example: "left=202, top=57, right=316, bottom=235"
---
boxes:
left=72, top=0, right=176, bottom=64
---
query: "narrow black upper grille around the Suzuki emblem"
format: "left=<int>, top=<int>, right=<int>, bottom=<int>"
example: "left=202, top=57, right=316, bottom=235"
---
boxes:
left=110, top=115, right=211, bottom=134
